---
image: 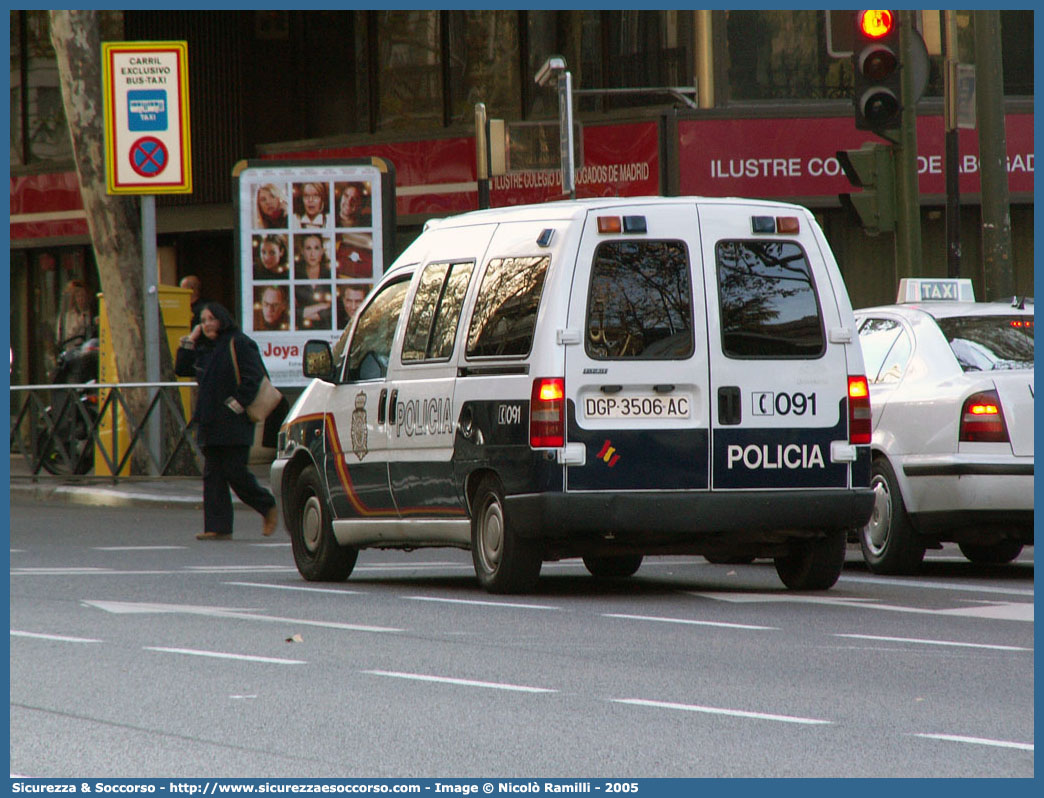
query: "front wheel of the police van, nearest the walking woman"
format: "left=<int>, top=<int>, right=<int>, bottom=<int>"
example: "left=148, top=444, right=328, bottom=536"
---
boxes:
left=289, top=466, right=359, bottom=582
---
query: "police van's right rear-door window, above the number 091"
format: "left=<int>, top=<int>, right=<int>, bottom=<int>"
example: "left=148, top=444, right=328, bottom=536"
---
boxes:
left=716, top=241, right=826, bottom=358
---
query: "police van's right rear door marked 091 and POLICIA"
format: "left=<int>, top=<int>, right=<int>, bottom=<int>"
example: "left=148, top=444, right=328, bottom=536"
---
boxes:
left=699, top=203, right=854, bottom=490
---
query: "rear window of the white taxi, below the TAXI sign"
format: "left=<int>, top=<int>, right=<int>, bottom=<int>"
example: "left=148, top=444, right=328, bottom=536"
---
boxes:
left=935, top=315, right=1034, bottom=372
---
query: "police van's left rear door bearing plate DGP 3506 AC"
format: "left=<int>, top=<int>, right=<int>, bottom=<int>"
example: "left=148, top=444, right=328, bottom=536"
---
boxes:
left=566, top=202, right=710, bottom=492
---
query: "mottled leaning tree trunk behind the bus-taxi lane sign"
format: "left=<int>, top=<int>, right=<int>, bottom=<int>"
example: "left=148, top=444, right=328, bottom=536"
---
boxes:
left=50, top=10, right=195, bottom=474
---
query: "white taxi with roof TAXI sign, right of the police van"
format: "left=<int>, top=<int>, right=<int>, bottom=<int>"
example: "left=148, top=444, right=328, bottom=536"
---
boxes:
left=855, top=279, right=1034, bottom=573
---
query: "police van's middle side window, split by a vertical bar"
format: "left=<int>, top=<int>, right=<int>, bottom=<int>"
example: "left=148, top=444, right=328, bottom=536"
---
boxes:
left=402, top=261, right=475, bottom=362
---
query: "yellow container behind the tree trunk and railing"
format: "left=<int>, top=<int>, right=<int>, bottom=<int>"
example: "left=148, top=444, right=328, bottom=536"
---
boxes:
left=94, top=285, right=192, bottom=476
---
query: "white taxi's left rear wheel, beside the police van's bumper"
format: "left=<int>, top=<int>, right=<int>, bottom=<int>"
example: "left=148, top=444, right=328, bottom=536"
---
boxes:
left=859, top=457, right=925, bottom=573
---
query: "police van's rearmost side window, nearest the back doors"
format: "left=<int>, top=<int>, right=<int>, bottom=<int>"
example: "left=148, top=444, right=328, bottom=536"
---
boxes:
left=467, top=255, right=551, bottom=357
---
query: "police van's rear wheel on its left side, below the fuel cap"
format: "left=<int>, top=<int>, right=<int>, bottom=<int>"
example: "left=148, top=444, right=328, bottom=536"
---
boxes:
left=471, top=476, right=542, bottom=593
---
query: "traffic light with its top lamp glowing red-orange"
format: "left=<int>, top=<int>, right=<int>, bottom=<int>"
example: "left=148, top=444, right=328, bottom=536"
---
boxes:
left=852, top=10, right=903, bottom=134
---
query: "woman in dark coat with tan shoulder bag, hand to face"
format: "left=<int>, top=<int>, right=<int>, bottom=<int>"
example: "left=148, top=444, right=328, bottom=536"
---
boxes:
left=174, top=302, right=279, bottom=540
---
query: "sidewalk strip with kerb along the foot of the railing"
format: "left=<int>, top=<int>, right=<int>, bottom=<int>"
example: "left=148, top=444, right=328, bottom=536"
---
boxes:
left=10, top=454, right=270, bottom=510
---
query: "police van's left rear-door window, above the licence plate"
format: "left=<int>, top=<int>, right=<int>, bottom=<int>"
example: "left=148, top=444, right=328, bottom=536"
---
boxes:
left=585, top=240, right=693, bottom=360
